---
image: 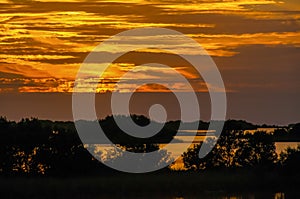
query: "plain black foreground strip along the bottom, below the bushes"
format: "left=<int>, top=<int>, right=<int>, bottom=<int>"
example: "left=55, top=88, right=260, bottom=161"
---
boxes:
left=0, top=171, right=300, bottom=199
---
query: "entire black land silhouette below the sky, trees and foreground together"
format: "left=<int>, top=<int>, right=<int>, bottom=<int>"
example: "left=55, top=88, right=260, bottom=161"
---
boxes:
left=0, top=115, right=300, bottom=198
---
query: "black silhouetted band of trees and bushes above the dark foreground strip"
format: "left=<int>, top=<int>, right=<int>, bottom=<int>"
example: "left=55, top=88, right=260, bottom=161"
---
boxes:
left=0, top=115, right=300, bottom=176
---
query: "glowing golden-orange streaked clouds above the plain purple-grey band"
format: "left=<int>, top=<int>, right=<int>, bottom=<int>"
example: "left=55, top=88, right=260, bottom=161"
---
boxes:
left=0, top=0, right=300, bottom=92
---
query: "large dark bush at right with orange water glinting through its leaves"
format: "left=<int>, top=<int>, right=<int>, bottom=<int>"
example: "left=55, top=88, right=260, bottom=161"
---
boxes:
left=183, top=130, right=277, bottom=170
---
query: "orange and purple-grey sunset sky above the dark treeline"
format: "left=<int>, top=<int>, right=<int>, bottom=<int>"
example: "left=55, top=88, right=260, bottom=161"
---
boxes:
left=0, top=0, right=300, bottom=124
